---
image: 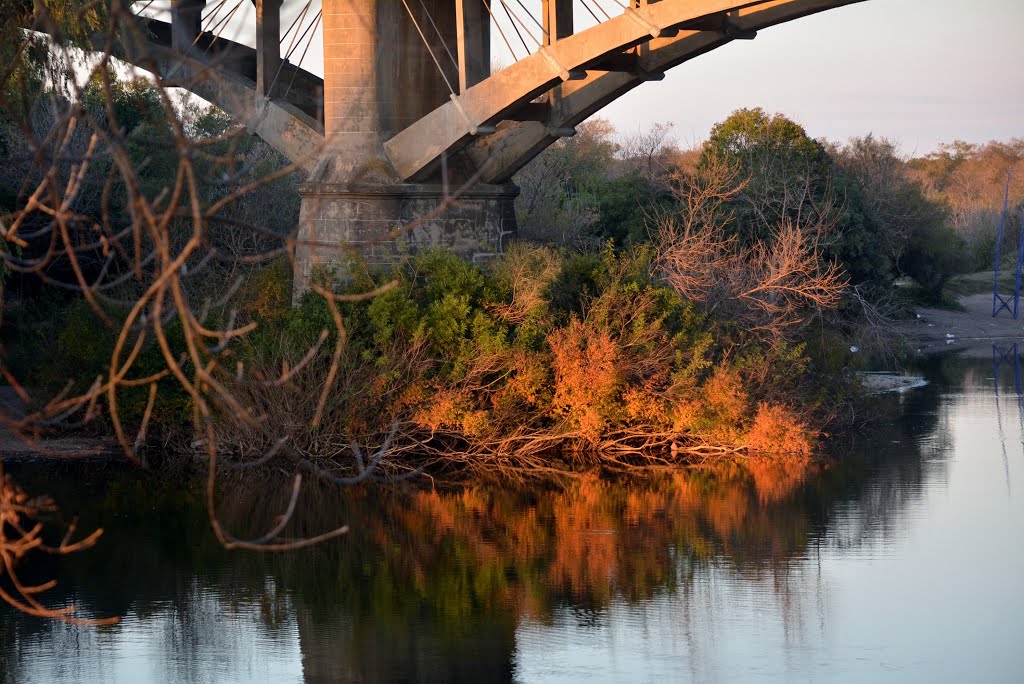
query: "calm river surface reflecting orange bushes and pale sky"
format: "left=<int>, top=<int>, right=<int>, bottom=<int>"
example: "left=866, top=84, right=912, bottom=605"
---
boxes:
left=0, top=350, right=1024, bottom=683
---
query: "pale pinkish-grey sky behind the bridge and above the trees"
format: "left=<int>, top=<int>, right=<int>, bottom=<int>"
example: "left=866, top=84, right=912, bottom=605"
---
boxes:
left=140, top=0, right=1024, bottom=155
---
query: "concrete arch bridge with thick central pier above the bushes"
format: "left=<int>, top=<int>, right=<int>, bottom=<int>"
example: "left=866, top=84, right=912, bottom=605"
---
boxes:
left=110, top=0, right=862, bottom=292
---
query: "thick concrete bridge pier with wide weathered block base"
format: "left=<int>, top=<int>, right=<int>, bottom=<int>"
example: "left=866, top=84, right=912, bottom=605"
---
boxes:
left=294, top=0, right=518, bottom=298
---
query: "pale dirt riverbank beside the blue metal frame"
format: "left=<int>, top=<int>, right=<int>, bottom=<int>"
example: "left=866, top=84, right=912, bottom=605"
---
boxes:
left=899, top=294, right=1024, bottom=356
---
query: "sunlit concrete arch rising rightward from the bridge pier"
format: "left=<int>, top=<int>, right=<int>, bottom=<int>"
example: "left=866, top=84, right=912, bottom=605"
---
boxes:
left=384, top=0, right=863, bottom=182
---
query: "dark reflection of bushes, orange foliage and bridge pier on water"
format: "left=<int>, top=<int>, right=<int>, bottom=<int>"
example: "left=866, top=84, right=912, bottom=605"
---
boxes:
left=0, top=360, right=966, bottom=682
